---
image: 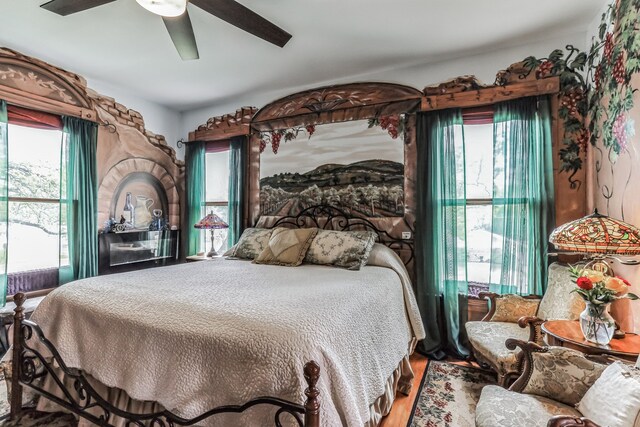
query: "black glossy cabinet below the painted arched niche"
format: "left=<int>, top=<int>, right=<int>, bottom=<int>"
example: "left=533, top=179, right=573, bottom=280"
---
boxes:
left=98, top=230, right=180, bottom=274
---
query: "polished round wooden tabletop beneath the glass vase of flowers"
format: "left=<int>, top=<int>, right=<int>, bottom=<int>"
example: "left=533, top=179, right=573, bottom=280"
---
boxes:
left=542, top=320, right=640, bottom=362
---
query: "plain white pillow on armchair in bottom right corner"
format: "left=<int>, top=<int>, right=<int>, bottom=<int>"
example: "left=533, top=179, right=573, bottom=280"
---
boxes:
left=578, top=362, right=640, bottom=427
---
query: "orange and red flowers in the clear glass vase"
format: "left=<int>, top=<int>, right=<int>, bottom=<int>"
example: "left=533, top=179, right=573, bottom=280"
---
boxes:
left=570, top=266, right=638, bottom=305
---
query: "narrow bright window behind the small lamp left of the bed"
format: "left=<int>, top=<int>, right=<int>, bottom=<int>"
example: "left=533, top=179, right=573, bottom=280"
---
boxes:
left=205, top=149, right=229, bottom=254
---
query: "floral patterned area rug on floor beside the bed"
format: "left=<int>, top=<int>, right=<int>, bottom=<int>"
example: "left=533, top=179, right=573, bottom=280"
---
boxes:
left=407, top=361, right=496, bottom=427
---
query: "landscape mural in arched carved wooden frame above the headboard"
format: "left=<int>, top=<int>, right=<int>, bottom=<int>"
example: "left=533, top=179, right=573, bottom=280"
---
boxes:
left=248, top=82, right=423, bottom=238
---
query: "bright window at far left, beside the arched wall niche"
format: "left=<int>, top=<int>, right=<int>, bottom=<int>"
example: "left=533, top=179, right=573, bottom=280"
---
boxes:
left=7, top=124, right=68, bottom=274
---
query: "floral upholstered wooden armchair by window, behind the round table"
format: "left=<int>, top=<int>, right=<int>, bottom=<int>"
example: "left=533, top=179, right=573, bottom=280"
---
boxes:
left=465, top=263, right=584, bottom=387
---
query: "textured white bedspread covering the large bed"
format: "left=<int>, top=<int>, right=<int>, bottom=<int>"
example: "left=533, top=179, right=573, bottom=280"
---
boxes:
left=32, top=245, right=424, bottom=427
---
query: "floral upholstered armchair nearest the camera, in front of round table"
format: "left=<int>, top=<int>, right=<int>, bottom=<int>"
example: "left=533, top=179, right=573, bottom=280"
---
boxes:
left=476, top=339, right=612, bottom=427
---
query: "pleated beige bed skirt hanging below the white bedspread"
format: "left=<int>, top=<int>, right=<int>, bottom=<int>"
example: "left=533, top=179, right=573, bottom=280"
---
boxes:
left=2, top=345, right=414, bottom=427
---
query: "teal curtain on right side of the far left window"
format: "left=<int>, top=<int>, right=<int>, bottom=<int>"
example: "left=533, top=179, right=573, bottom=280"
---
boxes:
left=59, top=116, right=98, bottom=285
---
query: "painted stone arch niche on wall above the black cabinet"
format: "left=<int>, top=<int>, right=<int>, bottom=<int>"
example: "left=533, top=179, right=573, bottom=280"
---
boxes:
left=98, top=157, right=180, bottom=231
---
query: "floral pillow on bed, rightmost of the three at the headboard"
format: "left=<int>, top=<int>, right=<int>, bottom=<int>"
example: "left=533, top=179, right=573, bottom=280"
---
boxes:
left=304, top=230, right=378, bottom=270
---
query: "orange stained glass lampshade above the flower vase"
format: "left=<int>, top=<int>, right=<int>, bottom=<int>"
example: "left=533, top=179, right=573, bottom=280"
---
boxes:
left=549, top=210, right=640, bottom=255
